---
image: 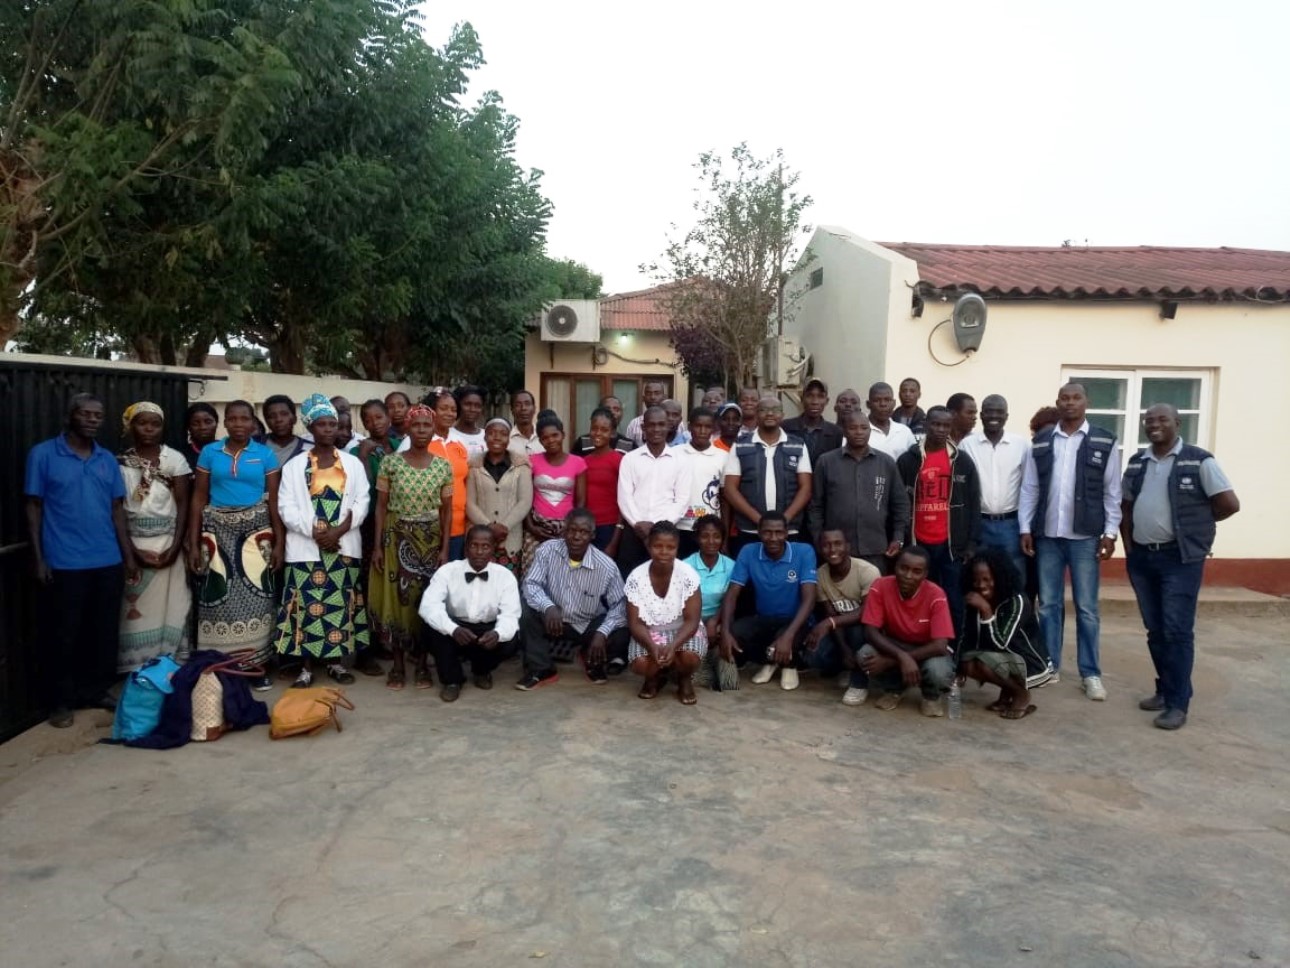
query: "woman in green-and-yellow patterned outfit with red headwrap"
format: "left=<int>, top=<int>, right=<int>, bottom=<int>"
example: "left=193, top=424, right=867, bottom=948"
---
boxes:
left=368, top=398, right=458, bottom=689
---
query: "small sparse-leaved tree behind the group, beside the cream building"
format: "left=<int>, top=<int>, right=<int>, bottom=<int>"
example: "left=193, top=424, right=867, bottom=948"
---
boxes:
left=641, top=145, right=811, bottom=386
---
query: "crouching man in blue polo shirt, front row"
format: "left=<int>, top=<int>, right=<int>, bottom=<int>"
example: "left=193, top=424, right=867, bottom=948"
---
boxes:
left=721, top=511, right=815, bottom=689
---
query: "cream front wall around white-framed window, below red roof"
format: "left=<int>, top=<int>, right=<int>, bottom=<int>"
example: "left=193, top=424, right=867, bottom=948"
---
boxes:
left=886, top=301, right=1290, bottom=558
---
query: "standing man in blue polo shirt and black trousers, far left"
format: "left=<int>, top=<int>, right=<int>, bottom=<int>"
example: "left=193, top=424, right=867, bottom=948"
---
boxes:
left=25, top=394, right=139, bottom=727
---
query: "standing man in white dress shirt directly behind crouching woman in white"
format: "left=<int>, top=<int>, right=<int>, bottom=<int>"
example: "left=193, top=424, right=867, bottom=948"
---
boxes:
left=618, top=407, right=693, bottom=574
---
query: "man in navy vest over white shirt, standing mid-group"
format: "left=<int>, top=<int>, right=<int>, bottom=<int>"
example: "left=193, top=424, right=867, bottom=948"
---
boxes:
left=722, top=396, right=811, bottom=551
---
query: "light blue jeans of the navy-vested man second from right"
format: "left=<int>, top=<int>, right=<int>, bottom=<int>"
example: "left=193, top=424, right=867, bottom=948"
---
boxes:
left=1035, top=538, right=1102, bottom=679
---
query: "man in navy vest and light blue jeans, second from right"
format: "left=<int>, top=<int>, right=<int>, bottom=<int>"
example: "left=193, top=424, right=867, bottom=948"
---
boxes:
left=1017, top=383, right=1121, bottom=702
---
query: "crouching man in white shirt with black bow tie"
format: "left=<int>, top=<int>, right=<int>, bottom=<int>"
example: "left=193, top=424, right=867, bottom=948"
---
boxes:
left=418, top=524, right=520, bottom=702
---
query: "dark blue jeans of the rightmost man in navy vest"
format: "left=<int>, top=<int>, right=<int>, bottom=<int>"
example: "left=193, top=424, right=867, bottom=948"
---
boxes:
left=1127, top=545, right=1205, bottom=712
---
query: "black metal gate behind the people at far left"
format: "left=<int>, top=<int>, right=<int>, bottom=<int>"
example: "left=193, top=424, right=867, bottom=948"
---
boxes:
left=0, top=354, right=190, bottom=742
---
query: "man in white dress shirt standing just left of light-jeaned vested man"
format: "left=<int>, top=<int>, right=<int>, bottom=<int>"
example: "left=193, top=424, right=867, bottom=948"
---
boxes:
left=960, top=394, right=1031, bottom=582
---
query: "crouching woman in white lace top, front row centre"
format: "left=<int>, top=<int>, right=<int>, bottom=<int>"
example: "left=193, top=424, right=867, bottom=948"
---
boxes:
left=624, top=521, right=708, bottom=706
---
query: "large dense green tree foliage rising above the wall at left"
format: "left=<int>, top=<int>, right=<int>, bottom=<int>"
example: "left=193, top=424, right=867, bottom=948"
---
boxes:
left=0, top=0, right=559, bottom=397
